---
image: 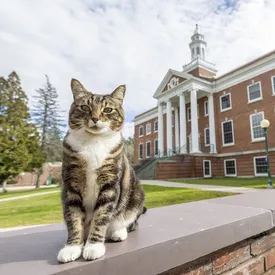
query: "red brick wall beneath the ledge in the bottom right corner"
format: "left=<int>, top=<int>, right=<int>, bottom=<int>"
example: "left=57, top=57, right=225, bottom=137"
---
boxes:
left=159, top=230, right=275, bottom=275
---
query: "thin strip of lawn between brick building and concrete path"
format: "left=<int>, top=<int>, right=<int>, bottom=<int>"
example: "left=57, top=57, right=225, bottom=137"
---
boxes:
left=169, top=178, right=275, bottom=188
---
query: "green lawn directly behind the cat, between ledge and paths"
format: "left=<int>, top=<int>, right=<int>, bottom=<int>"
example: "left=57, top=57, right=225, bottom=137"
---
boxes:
left=0, top=185, right=235, bottom=227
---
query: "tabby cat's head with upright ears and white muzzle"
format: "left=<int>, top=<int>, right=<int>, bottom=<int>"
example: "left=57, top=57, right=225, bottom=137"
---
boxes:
left=69, top=79, right=126, bottom=135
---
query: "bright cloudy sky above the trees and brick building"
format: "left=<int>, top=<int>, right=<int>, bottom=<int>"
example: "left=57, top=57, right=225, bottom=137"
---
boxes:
left=0, top=0, right=275, bottom=137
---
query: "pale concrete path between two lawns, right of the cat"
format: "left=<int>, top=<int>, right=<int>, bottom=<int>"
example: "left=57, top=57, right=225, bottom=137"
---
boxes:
left=140, top=180, right=263, bottom=194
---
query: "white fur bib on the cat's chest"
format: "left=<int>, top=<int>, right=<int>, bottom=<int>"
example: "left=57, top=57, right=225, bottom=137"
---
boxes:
left=68, top=133, right=121, bottom=216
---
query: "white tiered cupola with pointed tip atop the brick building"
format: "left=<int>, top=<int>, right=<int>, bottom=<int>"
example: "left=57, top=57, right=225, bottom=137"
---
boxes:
left=189, top=24, right=207, bottom=61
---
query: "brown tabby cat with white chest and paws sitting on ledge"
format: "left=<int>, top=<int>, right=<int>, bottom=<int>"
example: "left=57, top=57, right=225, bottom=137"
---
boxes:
left=57, top=79, right=146, bottom=263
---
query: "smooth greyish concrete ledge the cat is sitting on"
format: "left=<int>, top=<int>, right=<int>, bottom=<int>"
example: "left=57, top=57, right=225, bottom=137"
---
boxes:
left=0, top=190, right=275, bottom=275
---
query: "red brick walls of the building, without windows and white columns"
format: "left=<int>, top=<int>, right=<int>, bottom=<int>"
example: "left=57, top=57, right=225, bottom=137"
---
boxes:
left=134, top=51, right=275, bottom=179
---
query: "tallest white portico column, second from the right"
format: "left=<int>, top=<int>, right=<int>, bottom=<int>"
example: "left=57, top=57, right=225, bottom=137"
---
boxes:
left=190, top=89, right=200, bottom=153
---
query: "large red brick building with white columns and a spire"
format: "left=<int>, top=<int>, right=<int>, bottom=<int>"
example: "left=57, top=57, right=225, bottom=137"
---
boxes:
left=134, top=26, right=275, bottom=179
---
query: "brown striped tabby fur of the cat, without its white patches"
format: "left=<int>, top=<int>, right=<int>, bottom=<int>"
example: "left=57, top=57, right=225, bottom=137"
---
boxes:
left=58, top=79, right=146, bottom=261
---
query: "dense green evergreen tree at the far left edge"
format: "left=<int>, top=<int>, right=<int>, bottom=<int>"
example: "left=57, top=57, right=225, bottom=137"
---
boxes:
left=0, top=72, right=43, bottom=192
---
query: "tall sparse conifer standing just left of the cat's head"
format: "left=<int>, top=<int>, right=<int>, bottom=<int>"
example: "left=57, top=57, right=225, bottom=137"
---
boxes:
left=32, top=75, right=65, bottom=188
